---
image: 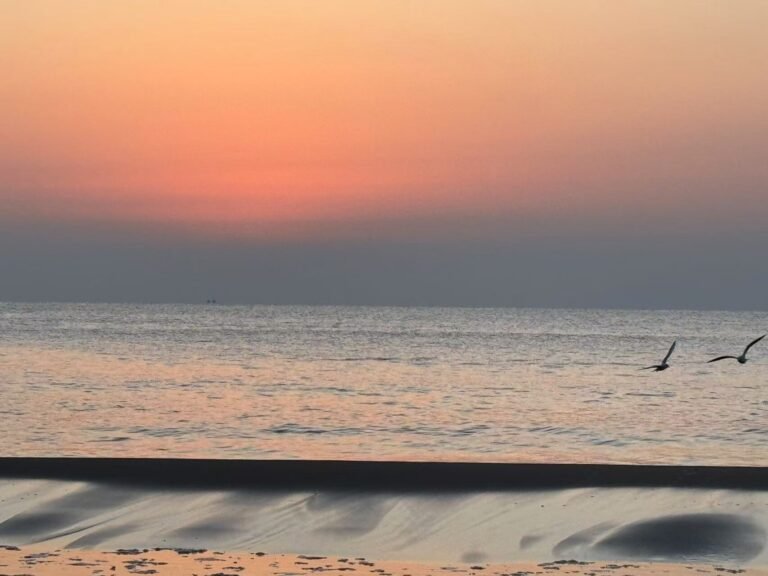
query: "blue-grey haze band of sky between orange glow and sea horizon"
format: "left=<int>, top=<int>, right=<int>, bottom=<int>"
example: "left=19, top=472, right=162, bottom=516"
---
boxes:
left=0, top=218, right=768, bottom=310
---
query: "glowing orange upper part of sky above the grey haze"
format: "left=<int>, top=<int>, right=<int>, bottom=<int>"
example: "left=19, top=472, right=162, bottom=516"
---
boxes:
left=6, top=0, right=768, bottom=238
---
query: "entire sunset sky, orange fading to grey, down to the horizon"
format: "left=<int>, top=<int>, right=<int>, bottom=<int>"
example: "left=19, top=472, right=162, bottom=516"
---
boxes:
left=0, top=0, right=768, bottom=310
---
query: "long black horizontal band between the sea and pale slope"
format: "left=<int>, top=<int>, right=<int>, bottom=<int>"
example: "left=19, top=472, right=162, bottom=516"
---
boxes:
left=0, top=457, right=768, bottom=492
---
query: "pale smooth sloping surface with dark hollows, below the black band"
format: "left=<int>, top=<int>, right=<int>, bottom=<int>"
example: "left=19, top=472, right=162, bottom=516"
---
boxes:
left=0, top=479, right=768, bottom=566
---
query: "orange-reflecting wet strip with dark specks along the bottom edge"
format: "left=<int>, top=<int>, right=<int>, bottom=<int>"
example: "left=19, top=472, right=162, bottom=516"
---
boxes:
left=0, top=547, right=768, bottom=576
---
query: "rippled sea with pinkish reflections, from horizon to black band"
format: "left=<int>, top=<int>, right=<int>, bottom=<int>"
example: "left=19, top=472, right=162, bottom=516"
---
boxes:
left=0, top=304, right=768, bottom=465
